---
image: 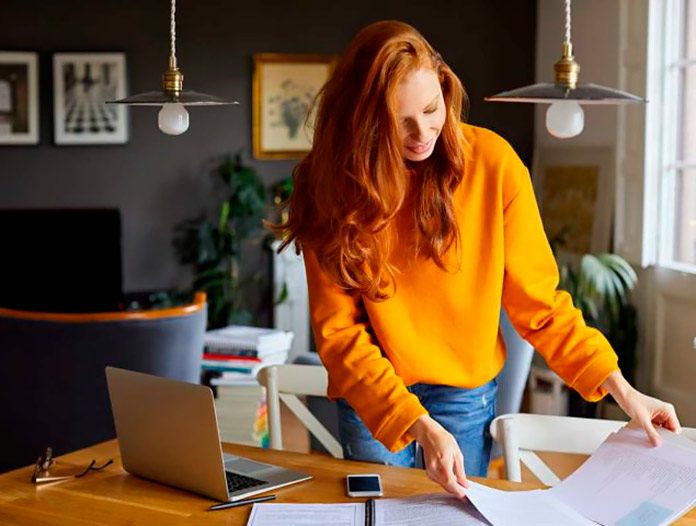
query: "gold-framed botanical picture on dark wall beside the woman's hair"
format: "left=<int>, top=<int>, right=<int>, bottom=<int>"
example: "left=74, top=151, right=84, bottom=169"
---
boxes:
left=253, top=53, right=338, bottom=159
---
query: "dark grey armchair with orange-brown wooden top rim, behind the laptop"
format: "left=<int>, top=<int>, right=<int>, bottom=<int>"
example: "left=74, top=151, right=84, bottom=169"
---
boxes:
left=0, top=293, right=206, bottom=472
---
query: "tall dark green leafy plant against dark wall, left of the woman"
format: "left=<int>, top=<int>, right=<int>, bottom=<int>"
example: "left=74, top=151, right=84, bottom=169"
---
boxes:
left=173, top=153, right=266, bottom=329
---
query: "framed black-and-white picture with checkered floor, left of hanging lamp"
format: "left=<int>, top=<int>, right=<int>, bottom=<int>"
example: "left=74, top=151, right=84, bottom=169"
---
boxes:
left=53, top=53, right=128, bottom=144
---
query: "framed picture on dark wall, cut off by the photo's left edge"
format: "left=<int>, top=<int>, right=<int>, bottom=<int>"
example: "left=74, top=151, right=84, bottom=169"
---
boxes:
left=0, top=51, right=39, bottom=144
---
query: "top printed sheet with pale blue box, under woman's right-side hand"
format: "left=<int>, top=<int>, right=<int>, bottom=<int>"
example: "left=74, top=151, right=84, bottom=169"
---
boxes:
left=549, top=428, right=696, bottom=526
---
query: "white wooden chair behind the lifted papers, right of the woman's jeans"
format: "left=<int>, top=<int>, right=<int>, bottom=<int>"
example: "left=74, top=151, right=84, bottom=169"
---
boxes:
left=490, top=413, right=696, bottom=486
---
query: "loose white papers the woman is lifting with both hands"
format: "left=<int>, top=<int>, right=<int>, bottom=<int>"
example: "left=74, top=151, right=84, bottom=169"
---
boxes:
left=467, top=428, right=696, bottom=526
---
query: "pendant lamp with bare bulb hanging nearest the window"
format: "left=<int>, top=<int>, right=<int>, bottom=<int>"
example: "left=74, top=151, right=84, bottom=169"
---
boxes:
left=485, top=0, right=646, bottom=139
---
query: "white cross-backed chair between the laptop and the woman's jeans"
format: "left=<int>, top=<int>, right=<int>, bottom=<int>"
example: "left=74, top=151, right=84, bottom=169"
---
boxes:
left=257, top=364, right=343, bottom=458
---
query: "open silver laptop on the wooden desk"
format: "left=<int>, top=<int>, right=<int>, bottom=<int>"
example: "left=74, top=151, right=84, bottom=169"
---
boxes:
left=106, top=367, right=312, bottom=501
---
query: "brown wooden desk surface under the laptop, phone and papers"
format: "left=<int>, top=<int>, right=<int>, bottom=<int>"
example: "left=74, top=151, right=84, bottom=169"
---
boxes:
left=0, top=440, right=696, bottom=526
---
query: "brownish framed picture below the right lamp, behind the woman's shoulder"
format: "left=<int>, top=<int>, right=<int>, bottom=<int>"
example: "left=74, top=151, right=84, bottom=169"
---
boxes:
left=534, top=147, right=615, bottom=255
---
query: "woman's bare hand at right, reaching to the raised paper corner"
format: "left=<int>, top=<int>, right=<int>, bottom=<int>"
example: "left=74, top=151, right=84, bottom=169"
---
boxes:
left=602, top=371, right=681, bottom=446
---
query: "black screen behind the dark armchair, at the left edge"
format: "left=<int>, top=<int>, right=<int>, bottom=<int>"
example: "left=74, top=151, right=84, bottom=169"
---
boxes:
left=0, top=208, right=123, bottom=312
